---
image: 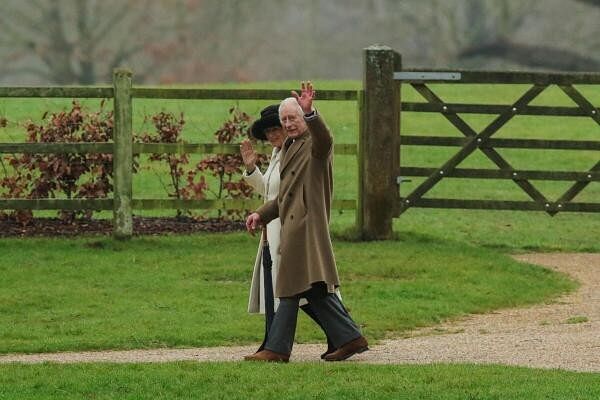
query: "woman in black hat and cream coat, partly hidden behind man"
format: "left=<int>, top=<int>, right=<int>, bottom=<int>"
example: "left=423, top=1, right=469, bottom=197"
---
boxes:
left=241, top=104, right=339, bottom=357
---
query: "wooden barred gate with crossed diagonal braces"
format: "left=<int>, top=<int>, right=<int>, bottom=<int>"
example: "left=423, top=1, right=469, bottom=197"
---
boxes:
left=391, top=59, right=600, bottom=225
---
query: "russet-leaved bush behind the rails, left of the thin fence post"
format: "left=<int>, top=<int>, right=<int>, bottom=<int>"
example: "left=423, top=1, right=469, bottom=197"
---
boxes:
left=0, top=101, right=114, bottom=224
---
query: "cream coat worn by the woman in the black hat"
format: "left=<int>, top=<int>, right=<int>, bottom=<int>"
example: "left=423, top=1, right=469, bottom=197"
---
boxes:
left=243, top=147, right=281, bottom=314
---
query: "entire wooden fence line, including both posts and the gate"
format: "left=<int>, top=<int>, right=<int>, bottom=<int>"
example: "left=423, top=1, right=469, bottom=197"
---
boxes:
left=0, top=46, right=600, bottom=240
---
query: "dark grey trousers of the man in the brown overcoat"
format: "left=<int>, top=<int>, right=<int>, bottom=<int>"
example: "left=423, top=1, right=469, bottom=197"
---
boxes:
left=265, top=284, right=361, bottom=354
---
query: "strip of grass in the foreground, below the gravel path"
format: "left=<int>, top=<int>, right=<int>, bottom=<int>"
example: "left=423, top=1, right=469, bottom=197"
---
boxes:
left=0, top=362, right=600, bottom=400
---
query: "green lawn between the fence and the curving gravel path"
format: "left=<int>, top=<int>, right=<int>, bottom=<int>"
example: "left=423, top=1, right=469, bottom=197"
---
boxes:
left=0, top=233, right=575, bottom=353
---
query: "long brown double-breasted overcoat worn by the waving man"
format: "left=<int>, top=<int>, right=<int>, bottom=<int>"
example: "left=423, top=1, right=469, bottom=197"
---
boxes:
left=257, top=115, right=339, bottom=297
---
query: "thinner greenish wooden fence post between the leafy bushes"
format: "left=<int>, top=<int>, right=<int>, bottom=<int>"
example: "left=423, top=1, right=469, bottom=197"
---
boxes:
left=113, top=68, right=133, bottom=239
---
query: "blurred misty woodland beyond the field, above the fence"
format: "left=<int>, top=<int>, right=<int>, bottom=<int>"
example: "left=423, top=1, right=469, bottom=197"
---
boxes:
left=0, top=0, right=600, bottom=84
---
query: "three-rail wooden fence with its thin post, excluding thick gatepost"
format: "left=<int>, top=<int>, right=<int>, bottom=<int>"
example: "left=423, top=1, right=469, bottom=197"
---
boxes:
left=0, top=69, right=360, bottom=238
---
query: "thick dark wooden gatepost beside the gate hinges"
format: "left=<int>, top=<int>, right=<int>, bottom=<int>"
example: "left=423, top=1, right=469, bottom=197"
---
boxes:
left=356, top=46, right=401, bottom=240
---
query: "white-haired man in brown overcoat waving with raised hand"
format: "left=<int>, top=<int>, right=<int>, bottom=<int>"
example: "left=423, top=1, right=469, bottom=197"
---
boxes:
left=245, top=82, right=368, bottom=362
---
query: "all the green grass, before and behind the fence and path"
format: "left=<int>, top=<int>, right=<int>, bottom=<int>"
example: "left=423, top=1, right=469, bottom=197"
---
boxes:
left=0, top=81, right=600, bottom=399
